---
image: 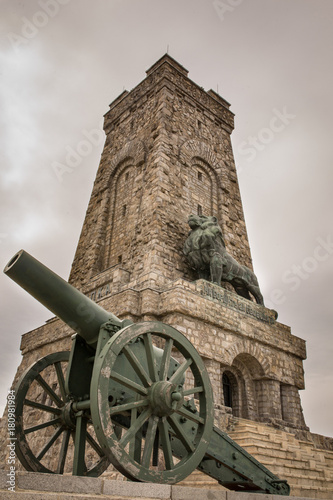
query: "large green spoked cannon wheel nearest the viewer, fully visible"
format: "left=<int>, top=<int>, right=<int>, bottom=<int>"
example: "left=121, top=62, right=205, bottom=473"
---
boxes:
left=90, top=322, right=213, bottom=484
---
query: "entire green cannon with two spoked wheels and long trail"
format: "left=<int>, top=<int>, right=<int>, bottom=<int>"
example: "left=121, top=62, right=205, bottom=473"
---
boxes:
left=4, top=250, right=290, bottom=495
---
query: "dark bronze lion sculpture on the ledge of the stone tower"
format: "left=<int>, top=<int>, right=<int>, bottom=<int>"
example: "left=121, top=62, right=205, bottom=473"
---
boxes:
left=183, top=215, right=264, bottom=305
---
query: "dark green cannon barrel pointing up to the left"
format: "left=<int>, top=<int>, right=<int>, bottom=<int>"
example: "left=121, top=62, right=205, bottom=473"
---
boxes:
left=4, top=250, right=122, bottom=345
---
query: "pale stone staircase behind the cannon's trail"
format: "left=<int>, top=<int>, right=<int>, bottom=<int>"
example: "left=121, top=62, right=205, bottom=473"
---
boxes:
left=180, top=419, right=333, bottom=500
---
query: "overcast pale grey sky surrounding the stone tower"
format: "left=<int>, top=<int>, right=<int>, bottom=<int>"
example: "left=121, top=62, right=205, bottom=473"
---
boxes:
left=0, top=0, right=333, bottom=436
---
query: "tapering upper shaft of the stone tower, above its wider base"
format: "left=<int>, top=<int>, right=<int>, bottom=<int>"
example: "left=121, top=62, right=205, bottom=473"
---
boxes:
left=70, top=55, right=251, bottom=292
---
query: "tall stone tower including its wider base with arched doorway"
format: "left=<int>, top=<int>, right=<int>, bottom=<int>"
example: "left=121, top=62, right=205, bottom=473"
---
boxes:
left=65, top=55, right=306, bottom=429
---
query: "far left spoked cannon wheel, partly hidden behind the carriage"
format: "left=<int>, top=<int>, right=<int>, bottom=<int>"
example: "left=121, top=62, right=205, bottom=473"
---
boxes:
left=15, top=351, right=110, bottom=477
